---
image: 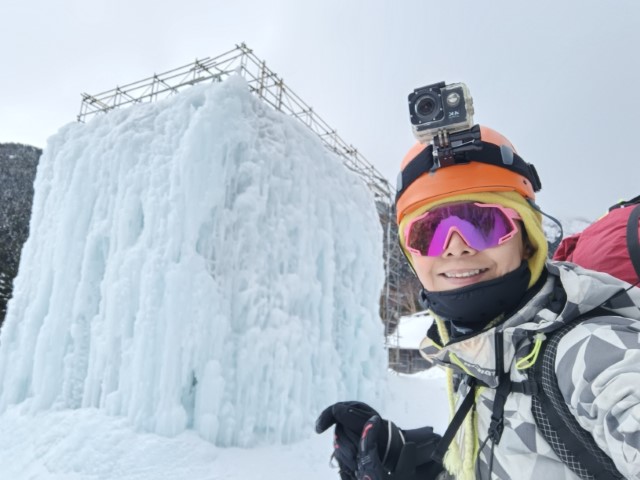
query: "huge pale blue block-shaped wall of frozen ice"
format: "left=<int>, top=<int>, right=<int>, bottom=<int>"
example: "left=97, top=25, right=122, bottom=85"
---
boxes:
left=0, top=77, right=386, bottom=446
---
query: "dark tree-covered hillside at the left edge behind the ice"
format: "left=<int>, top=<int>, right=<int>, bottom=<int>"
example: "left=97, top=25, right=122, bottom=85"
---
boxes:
left=0, top=143, right=42, bottom=325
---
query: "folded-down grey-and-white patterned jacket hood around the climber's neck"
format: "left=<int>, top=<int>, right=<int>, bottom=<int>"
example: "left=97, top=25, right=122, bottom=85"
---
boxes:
left=420, top=261, right=640, bottom=388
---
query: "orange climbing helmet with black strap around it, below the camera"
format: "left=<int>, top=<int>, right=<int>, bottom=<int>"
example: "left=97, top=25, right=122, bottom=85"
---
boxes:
left=396, top=125, right=542, bottom=224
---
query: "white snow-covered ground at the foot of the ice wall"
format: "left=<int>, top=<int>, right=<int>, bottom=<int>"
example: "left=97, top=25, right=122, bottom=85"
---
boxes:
left=0, top=369, right=448, bottom=480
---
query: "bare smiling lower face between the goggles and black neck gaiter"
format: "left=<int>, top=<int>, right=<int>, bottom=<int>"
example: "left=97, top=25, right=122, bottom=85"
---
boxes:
left=411, top=226, right=528, bottom=292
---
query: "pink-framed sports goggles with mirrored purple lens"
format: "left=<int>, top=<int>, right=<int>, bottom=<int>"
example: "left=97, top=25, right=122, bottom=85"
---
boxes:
left=404, top=202, right=521, bottom=257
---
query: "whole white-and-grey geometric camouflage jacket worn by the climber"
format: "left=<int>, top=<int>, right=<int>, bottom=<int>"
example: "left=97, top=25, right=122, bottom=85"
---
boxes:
left=421, top=262, right=640, bottom=480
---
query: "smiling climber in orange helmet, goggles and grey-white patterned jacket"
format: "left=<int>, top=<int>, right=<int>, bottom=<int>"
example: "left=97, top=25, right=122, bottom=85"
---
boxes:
left=316, top=125, right=640, bottom=480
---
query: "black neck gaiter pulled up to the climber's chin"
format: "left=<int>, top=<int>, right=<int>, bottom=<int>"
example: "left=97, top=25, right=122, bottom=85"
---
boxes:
left=420, top=261, right=531, bottom=333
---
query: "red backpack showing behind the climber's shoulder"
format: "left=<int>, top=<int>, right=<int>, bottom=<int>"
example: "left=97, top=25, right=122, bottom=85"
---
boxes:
left=553, top=195, right=640, bottom=284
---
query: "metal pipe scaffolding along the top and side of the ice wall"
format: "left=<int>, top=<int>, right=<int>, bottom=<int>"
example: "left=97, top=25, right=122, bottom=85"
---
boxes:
left=78, top=43, right=403, bottom=338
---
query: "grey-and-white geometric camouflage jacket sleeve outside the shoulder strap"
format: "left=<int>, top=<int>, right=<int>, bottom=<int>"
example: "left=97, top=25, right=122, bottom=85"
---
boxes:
left=556, top=316, right=640, bottom=478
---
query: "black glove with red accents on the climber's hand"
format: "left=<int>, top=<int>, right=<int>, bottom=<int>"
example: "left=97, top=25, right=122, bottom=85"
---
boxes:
left=316, top=402, right=442, bottom=480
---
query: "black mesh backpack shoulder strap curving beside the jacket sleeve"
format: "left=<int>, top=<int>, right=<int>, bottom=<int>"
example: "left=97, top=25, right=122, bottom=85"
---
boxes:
left=531, top=308, right=624, bottom=480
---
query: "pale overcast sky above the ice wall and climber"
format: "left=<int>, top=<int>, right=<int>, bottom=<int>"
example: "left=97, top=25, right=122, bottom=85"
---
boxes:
left=0, top=0, right=640, bottom=218
